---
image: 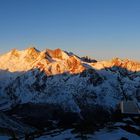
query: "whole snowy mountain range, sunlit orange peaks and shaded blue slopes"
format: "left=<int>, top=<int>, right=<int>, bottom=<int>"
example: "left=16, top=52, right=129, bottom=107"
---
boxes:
left=0, top=48, right=140, bottom=128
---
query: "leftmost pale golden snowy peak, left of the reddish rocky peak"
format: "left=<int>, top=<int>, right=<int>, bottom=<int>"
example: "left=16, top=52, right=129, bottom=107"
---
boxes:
left=0, top=48, right=40, bottom=72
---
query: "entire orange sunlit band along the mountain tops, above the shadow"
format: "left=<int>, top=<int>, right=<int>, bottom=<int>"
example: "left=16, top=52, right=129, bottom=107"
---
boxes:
left=0, top=47, right=140, bottom=75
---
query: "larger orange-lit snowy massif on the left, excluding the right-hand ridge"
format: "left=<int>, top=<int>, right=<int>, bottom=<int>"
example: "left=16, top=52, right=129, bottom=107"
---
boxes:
left=0, top=48, right=85, bottom=75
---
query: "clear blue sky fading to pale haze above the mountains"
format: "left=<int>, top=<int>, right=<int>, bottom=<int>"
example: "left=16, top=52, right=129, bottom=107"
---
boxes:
left=0, top=0, right=140, bottom=60
